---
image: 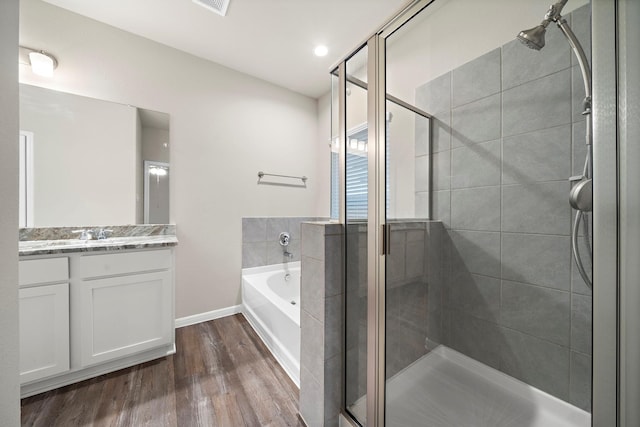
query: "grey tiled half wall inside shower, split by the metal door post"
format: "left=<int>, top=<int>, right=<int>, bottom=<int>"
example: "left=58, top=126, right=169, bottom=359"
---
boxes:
left=345, top=220, right=446, bottom=412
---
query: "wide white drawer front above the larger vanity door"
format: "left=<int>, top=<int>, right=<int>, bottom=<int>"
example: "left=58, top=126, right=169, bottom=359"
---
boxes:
left=74, top=249, right=171, bottom=279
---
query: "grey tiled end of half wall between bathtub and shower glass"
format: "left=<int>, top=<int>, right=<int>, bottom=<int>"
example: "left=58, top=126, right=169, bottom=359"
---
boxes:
left=299, top=222, right=344, bottom=427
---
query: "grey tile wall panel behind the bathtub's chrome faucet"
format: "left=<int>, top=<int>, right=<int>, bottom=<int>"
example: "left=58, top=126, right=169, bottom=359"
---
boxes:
left=242, top=217, right=326, bottom=268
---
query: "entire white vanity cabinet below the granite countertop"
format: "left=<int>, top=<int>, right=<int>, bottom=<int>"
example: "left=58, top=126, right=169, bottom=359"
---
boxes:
left=20, top=246, right=175, bottom=397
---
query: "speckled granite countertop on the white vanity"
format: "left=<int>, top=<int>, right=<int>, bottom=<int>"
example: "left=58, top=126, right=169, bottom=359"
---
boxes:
left=18, top=225, right=178, bottom=256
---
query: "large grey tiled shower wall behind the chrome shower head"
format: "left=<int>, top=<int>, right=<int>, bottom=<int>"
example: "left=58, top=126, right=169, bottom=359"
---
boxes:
left=416, top=6, right=592, bottom=410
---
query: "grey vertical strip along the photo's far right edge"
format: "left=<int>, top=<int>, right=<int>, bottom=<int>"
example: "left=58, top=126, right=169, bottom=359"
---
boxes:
left=617, top=0, right=640, bottom=426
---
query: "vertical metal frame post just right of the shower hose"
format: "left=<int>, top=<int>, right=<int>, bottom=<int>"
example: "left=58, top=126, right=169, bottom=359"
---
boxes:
left=591, top=0, right=620, bottom=427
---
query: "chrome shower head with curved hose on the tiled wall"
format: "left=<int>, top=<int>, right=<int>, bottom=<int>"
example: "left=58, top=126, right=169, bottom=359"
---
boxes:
left=517, top=0, right=593, bottom=288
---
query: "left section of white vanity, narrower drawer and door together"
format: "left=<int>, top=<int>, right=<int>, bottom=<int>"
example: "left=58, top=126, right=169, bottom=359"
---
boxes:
left=18, top=257, right=69, bottom=383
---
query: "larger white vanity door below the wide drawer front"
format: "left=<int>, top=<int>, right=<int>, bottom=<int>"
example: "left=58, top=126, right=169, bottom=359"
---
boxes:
left=74, top=271, right=173, bottom=366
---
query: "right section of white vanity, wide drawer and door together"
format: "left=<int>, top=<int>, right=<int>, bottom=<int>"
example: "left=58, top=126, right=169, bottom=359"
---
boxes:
left=72, top=249, right=174, bottom=367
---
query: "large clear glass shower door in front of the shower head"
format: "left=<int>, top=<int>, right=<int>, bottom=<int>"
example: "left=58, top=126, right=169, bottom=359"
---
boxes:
left=380, top=0, right=592, bottom=427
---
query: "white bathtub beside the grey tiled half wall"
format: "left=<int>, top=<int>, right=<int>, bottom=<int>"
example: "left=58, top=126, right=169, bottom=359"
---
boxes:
left=242, top=262, right=300, bottom=387
